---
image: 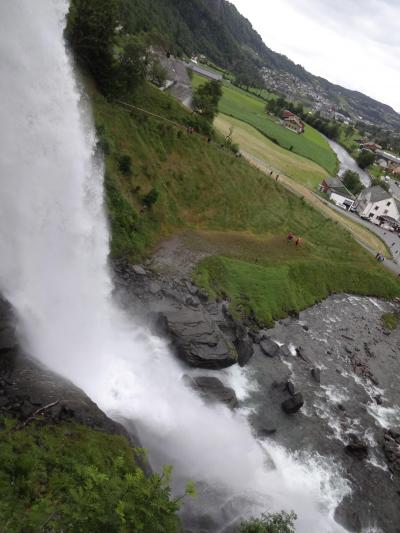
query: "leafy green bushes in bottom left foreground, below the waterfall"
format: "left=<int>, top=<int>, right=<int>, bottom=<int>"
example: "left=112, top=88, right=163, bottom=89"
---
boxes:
left=0, top=420, right=181, bottom=533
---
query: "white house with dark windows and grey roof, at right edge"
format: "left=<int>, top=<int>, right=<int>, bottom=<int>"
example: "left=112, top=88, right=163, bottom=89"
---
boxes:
left=354, top=185, right=400, bottom=224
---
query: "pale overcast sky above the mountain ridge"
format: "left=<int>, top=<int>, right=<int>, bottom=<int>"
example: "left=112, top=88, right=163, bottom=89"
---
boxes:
left=230, top=0, right=400, bottom=112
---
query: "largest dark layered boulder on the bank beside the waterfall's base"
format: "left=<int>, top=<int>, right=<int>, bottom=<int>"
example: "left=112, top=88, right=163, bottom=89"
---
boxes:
left=156, top=308, right=237, bottom=370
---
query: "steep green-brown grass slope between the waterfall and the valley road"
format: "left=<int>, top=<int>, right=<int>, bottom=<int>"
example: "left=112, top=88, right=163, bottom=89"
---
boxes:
left=91, top=79, right=400, bottom=321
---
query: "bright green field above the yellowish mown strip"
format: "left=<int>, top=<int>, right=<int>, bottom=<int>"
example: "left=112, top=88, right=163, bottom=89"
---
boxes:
left=193, top=70, right=338, bottom=175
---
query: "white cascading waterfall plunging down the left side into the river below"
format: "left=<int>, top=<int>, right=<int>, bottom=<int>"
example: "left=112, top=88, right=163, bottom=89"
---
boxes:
left=0, top=0, right=350, bottom=533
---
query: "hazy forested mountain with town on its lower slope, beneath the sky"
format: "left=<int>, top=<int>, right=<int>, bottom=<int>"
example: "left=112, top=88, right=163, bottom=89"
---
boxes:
left=121, top=0, right=400, bottom=130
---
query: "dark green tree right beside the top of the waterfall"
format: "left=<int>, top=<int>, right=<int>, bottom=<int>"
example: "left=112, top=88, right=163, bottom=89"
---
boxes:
left=65, top=0, right=119, bottom=93
